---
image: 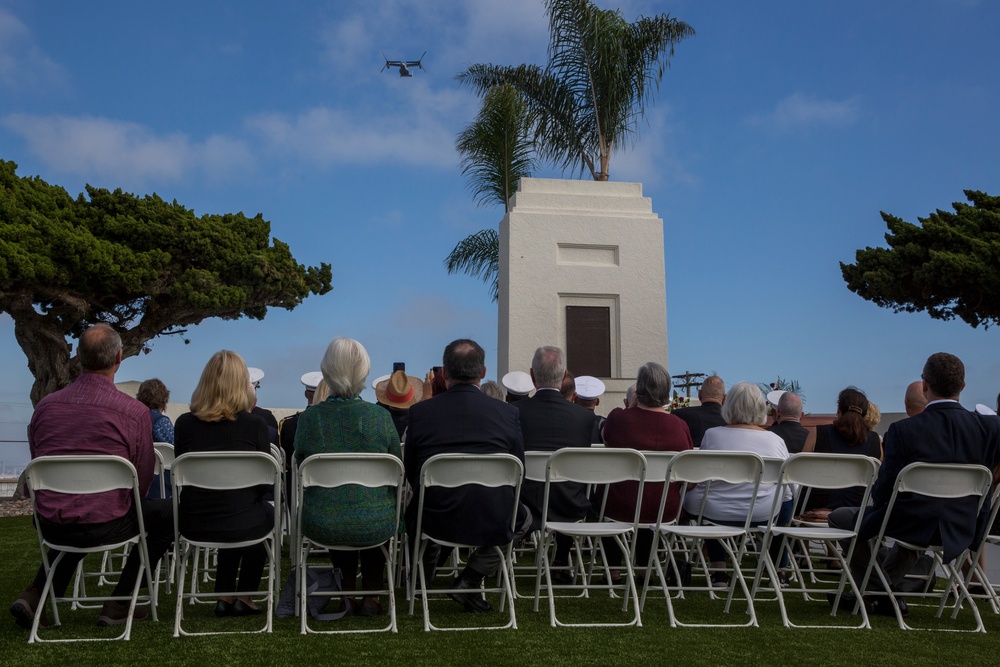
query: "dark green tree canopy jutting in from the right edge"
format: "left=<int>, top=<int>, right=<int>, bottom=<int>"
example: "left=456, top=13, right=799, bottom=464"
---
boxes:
left=840, top=190, right=1000, bottom=328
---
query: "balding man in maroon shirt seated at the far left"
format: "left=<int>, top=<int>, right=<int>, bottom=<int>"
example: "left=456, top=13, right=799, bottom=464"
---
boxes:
left=10, top=324, right=173, bottom=628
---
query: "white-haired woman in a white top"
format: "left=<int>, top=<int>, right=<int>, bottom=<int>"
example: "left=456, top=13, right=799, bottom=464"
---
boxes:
left=684, top=382, right=791, bottom=586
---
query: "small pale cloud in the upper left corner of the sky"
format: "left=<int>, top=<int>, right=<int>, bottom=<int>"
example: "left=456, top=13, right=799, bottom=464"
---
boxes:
left=0, top=7, right=67, bottom=93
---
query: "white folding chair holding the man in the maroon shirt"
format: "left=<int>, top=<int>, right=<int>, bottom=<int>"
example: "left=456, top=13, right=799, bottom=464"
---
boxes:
left=24, top=455, right=156, bottom=644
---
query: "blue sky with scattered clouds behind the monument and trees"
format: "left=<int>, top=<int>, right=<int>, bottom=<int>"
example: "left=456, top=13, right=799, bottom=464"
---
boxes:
left=0, top=0, right=1000, bottom=444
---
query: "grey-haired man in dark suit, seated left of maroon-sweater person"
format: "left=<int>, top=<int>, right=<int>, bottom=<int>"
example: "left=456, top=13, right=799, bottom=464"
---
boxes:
left=514, top=346, right=594, bottom=565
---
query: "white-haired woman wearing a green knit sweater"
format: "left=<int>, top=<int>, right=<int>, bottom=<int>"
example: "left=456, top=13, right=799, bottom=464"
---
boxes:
left=295, top=338, right=401, bottom=616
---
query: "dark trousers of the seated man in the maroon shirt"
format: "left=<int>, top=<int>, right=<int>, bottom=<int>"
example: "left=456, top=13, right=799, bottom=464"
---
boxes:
left=32, top=498, right=174, bottom=597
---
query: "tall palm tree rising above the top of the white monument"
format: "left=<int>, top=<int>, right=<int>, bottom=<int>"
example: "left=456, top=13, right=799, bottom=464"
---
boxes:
left=457, top=0, right=694, bottom=181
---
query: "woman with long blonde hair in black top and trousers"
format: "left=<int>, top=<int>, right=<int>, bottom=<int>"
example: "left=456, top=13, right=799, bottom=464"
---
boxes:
left=174, top=350, right=274, bottom=616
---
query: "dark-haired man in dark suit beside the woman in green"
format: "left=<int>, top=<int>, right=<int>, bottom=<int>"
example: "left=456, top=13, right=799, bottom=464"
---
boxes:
left=403, top=339, right=531, bottom=612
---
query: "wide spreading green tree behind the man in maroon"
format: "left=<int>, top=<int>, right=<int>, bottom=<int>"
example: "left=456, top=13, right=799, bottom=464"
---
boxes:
left=0, top=161, right=332, bottom=403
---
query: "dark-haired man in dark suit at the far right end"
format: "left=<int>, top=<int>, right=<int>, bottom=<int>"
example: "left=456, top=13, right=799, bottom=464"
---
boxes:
left=830, top=352, right=1000, bottom=600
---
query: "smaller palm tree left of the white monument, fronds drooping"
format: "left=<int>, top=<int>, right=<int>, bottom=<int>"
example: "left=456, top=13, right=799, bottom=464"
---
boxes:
left=445, top=84, right=535, bottom=301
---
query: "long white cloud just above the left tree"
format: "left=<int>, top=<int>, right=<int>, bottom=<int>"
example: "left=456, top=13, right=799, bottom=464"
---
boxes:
left=0, top=114, right=252, bottom=188
